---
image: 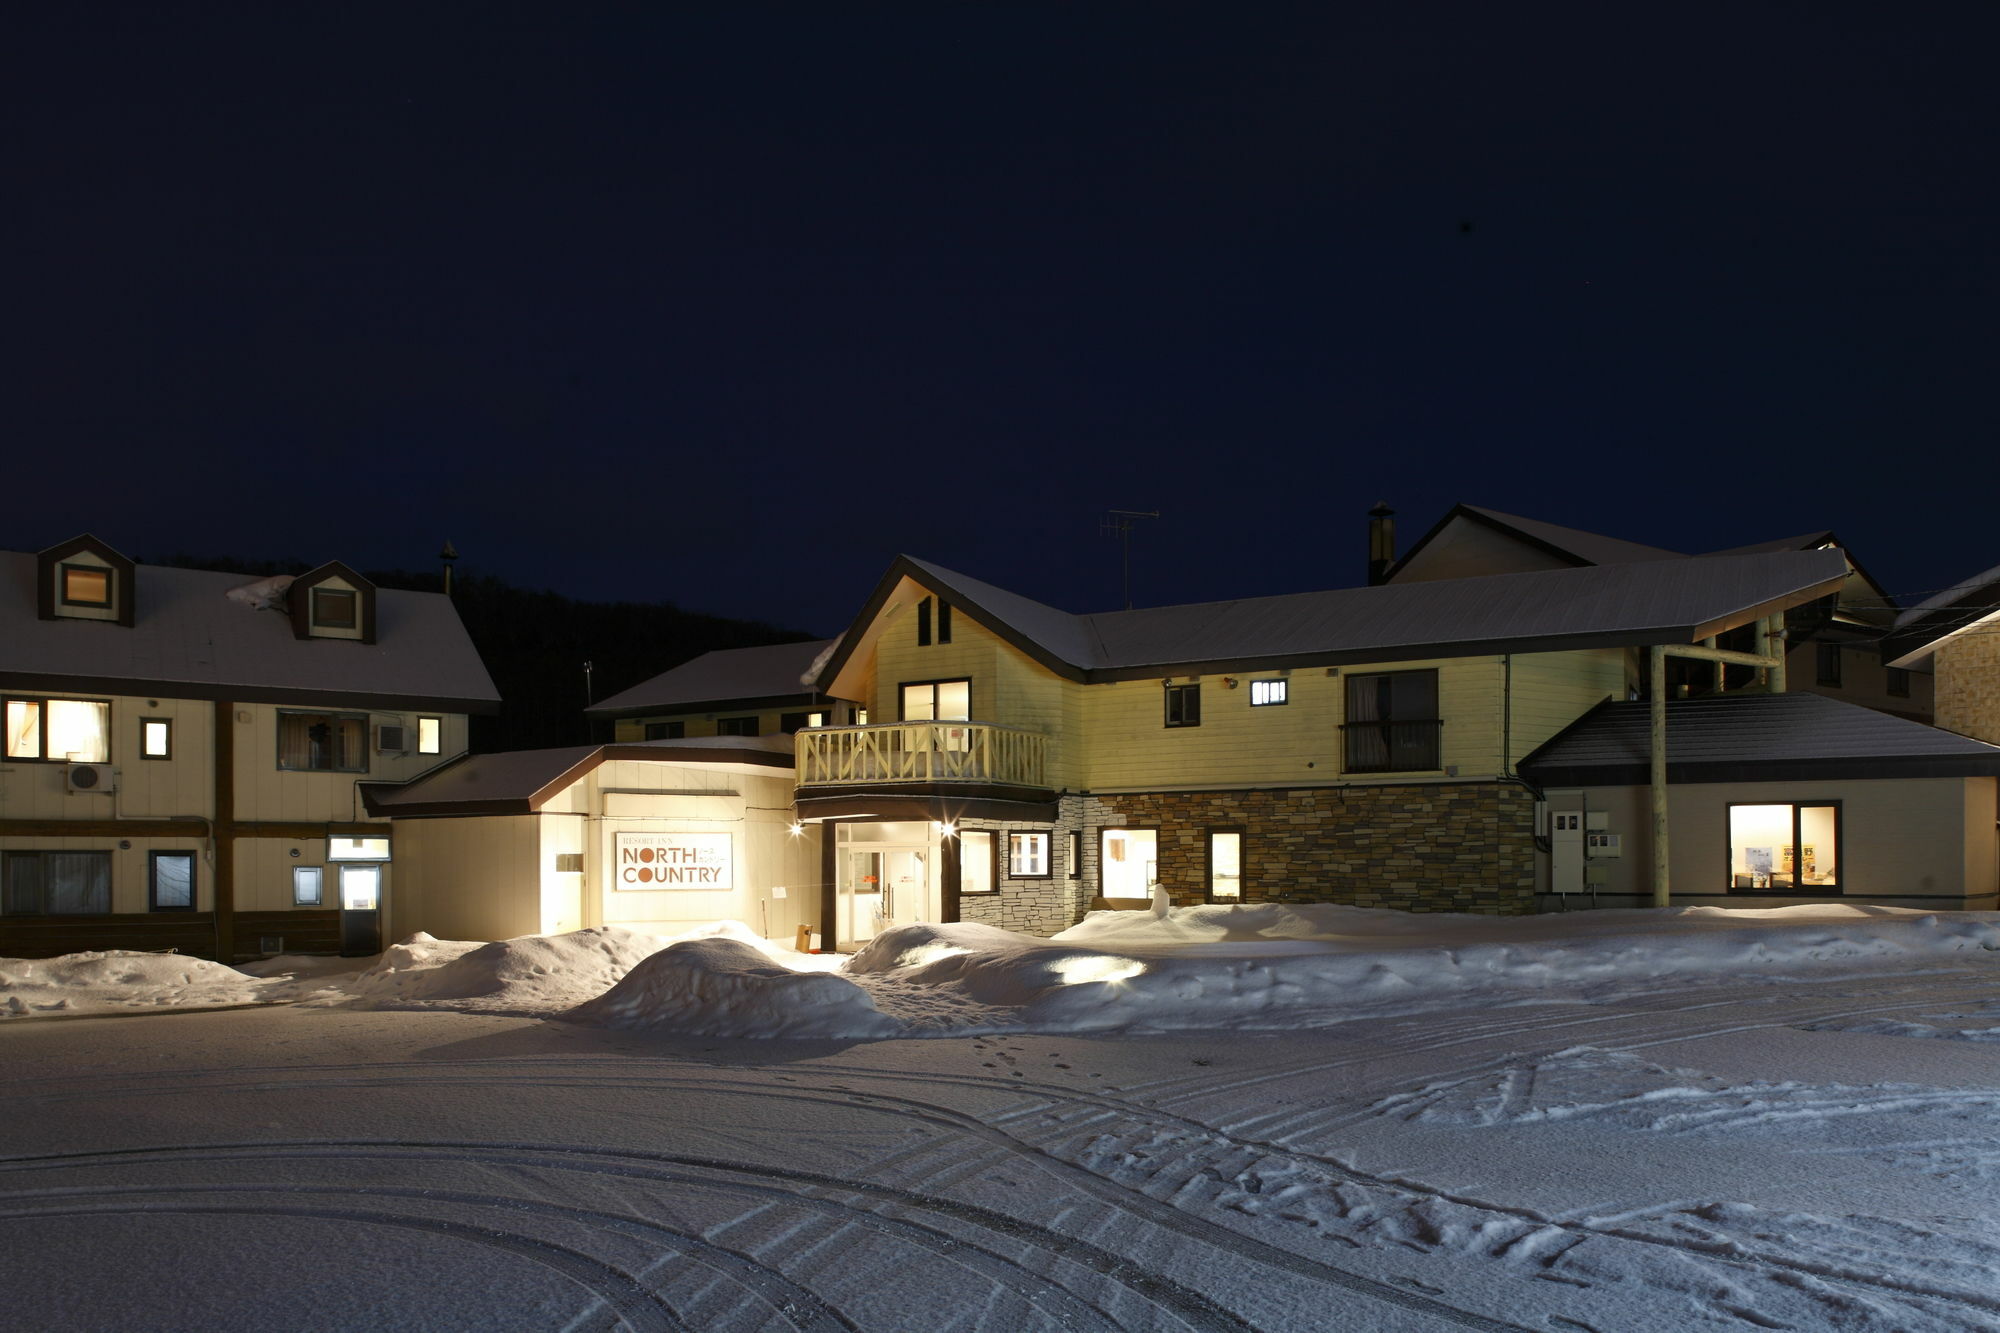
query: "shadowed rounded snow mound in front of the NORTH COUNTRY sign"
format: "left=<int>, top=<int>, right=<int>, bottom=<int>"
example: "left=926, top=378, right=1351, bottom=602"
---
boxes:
left=562, top=939, right=902, bottom=1039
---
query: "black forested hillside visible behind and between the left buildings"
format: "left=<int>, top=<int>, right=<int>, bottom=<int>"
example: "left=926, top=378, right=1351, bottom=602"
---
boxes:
left=146, top=554, right=812, bottom=753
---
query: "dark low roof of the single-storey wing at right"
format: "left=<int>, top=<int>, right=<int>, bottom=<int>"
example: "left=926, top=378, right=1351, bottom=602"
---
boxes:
left=1520, top=695, right=2000, bottom=787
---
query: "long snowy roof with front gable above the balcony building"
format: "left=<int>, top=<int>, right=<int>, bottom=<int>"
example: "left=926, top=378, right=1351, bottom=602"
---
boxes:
left=820, top=550, right=1846, bottom=693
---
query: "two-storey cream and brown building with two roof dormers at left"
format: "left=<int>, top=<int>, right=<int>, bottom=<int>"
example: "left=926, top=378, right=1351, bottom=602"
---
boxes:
left=0, top=534, right=498, bottom=961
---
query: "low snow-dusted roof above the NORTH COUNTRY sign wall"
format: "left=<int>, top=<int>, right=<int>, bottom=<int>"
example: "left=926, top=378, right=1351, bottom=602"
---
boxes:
left=360, top=737, right=792, bottom=819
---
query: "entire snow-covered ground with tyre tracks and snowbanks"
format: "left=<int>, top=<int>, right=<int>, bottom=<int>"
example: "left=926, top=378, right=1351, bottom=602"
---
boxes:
left=0, top=907, right=2000, bottom=1333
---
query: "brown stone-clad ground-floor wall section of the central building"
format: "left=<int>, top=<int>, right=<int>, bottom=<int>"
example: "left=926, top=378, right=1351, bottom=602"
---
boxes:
left=1084, top=783, right=1534, bottom=915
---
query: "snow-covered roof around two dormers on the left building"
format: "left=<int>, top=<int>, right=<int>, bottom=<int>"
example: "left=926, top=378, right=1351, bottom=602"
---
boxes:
left=0, top=550, right=500, bottom=713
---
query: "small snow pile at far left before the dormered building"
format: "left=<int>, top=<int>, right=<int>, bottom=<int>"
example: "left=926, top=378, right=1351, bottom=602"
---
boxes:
left=0, top=949, right=282, bottom=1019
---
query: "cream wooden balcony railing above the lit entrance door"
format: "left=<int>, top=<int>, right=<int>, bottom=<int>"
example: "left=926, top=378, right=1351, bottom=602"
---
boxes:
left=798, top=723, right=1048, bottom=787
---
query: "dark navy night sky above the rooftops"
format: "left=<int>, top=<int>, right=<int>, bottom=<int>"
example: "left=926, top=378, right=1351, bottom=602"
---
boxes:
left=0, top=0, right=2000, bottom=632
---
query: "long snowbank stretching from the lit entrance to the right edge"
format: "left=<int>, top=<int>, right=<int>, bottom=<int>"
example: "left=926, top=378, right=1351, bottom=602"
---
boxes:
left=848, top=905, right=2000, bottom=1033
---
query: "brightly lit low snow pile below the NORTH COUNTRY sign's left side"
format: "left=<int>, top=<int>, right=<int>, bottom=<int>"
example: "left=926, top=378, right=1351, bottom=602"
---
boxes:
left=342, top=921, right=780, bottom=1015
